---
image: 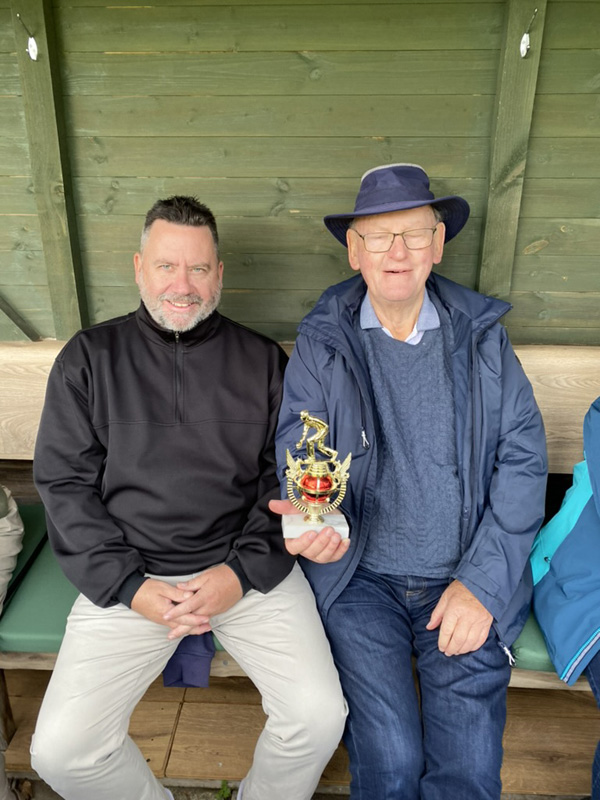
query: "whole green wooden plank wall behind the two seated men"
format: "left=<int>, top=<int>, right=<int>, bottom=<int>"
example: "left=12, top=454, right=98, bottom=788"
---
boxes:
left=0, top=0, right=600, bottom=344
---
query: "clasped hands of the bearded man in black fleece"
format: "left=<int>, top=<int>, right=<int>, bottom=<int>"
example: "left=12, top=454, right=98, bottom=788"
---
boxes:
left=131, top=564, right=243, bottom=639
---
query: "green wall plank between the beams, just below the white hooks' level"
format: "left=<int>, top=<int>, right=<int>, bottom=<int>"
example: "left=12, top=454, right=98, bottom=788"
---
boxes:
left=61, top=49, right=500, bottom=97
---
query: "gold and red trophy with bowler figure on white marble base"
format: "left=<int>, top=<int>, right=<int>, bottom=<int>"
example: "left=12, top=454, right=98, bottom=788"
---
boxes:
left=282, top=411, right=352, bottom=539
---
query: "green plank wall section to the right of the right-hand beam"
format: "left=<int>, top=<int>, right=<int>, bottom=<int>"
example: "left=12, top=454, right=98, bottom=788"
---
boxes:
left=509, top=0, right=600, bottom=344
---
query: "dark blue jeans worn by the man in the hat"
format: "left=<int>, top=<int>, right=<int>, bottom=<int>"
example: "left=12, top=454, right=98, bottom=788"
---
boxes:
left=326, top=568, right=510, bottom=800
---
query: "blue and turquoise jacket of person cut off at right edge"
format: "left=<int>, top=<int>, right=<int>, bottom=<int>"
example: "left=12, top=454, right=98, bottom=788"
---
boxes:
left=531, top=397, right=600, bottom=685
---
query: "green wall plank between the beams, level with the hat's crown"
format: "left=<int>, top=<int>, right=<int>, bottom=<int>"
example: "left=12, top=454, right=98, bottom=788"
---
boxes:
left=69, top=135, right=492, bottom=180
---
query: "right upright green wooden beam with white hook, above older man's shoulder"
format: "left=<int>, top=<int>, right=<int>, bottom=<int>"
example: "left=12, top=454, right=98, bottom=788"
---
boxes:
left=478, top=0, right=546, bottom=298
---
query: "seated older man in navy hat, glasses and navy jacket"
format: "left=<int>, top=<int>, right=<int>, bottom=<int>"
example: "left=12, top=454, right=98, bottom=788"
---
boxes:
left=271, top=164, right=547, bottom=800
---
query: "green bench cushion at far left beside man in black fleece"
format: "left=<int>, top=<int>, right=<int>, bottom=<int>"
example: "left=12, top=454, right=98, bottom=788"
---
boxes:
left=0, top=542, right=78, bottom=653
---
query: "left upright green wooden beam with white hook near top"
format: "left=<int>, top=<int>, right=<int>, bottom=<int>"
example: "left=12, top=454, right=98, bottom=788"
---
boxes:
left=11, top=0, right=88, bottom=339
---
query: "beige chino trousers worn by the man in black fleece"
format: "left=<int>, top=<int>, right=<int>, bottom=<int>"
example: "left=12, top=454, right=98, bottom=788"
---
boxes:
left=31, top=565, right=346, bottom=800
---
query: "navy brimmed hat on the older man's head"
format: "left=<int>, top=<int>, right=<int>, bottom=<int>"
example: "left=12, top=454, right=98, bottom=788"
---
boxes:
left=323, top=164, right=470, bottom=246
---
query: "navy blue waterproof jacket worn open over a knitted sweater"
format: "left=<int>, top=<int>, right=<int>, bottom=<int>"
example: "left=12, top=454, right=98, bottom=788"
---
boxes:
left=277, top=274, right=547, bottom=645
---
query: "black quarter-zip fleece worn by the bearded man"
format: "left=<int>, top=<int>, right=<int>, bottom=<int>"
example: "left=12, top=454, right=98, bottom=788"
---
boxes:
left=34, top=304, right=293, bottom=606
